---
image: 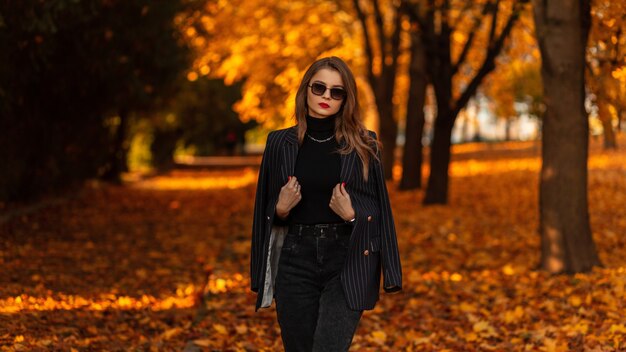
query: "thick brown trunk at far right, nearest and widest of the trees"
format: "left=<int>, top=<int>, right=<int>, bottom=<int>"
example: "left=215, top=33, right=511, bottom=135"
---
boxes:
left=533, top=0, right=600, bottom=273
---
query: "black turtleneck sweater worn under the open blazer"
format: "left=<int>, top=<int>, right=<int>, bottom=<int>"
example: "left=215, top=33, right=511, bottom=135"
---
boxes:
left=274, top=115, right=344, bottom=224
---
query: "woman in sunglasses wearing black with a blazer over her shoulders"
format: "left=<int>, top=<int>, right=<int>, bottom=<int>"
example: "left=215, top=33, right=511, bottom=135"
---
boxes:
left=250, top=56, right=402, bottom=352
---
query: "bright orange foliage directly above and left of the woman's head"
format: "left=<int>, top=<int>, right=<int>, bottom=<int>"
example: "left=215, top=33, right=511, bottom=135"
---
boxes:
left=179, top=0, right=357, bottom=133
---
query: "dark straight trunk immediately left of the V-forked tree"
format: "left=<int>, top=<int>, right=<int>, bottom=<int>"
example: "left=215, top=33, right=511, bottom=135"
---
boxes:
left=399, top=33, right=428, bottom=189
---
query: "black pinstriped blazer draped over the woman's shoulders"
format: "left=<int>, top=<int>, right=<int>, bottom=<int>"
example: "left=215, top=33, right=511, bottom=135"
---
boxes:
left=250, top=126, right=402, bottom=311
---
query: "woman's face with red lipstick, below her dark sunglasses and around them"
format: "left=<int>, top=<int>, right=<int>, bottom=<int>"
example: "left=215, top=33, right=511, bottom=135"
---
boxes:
left=306, top=68, right=346, bottom=119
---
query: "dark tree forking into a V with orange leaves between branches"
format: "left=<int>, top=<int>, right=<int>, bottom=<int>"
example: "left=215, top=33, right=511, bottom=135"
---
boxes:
left=403, top=0, right=527, bottom=204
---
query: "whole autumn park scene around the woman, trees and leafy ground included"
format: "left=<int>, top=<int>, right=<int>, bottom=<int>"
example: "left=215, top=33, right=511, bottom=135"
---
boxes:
left=0, top=0, right=626, bottom=352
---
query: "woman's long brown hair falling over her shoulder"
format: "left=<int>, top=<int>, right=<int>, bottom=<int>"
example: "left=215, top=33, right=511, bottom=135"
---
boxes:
left=295, top=56, right=382, bottom=181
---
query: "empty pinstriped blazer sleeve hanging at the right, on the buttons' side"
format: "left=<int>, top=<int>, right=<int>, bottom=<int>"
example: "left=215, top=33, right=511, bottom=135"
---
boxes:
left=371, top=131, right=402, bottom=293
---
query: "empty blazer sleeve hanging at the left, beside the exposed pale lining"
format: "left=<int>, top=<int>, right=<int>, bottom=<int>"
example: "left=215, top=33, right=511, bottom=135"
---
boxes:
left=250, top=132, right=273, bottom=292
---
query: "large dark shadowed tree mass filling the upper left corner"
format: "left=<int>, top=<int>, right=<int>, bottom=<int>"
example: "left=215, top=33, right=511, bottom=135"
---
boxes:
left=0, top=0, right=188, bottom=199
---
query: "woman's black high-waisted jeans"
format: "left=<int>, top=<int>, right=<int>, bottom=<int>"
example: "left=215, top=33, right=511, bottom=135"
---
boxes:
left=274, top=225, right=363, bottom=352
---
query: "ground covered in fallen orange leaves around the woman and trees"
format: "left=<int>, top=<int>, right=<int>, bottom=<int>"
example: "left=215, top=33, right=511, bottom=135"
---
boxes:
left=0, top=138, right=626, bottom=351
